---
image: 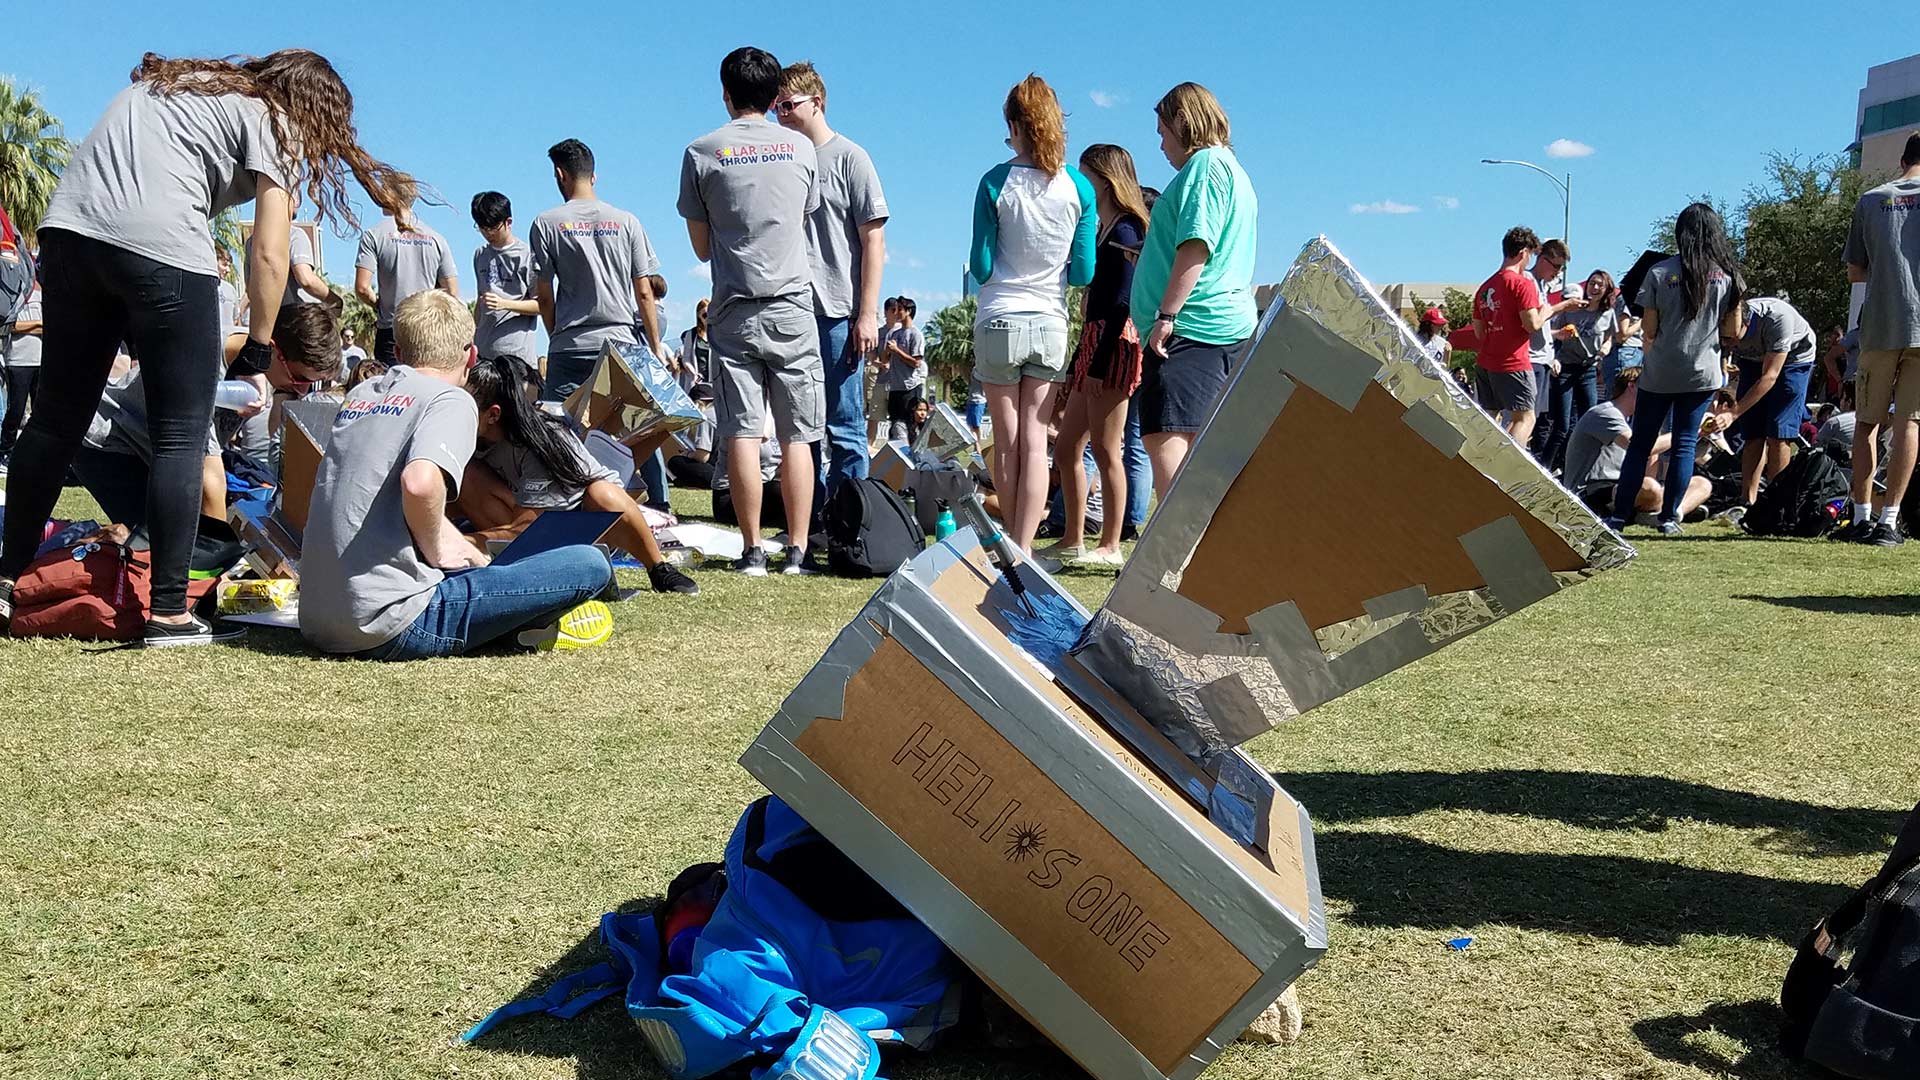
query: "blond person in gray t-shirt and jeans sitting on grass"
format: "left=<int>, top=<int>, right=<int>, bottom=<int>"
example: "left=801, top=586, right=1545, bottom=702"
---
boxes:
left=300, top=290, right=612, bottom=659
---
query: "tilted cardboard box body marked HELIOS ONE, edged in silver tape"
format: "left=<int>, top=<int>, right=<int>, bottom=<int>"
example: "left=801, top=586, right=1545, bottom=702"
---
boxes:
left=741, top=528, right=1325, bottom=1080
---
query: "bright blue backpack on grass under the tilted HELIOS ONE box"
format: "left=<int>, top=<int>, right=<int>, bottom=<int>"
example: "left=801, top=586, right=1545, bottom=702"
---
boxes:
left=461, top=796, right=966, bottom=1080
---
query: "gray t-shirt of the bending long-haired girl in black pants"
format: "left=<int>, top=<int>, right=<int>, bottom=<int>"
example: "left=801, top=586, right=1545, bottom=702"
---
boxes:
left=40, top=83, right=296, bottom=277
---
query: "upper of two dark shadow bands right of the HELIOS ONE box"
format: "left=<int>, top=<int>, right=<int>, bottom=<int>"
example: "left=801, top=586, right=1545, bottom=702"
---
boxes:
left=1275, top=769, right=1907, bottom=857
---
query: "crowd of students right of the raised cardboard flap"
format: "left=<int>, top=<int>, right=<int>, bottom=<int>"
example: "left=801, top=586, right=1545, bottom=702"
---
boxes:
left=1459, top=135, right=1920, bottom=548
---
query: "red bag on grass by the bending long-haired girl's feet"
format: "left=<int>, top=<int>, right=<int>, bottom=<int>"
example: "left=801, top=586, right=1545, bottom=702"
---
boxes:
left=10, top=532, right=217, bottom=642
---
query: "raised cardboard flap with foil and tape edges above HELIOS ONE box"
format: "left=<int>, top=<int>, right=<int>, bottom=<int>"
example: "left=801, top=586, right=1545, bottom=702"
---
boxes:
left=1075, top=236, right=1634, bottom=757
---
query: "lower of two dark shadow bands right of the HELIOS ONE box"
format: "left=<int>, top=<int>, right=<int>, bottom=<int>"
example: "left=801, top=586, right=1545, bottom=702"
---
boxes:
left=1313, top=830, right=1849, bottom=945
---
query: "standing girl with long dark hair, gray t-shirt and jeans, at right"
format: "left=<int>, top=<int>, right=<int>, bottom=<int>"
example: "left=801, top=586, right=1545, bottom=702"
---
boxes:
left=1609, top=202, right=1747, bottom=536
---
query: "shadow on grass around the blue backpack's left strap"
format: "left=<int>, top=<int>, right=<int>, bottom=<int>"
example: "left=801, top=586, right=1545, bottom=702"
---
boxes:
left=468, top=896, right=666, bottom=1080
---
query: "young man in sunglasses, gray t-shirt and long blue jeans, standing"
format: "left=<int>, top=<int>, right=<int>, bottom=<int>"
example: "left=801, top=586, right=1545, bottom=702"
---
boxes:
left=774, top=61, right=887, bottom=507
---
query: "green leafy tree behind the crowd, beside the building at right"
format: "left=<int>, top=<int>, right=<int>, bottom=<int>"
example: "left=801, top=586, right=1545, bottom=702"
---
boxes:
left=1634, top=152, right=1868, bottom=331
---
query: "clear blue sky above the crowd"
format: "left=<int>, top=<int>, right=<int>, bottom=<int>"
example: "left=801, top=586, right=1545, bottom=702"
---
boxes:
left=15, top=0, right=1920, bottom=332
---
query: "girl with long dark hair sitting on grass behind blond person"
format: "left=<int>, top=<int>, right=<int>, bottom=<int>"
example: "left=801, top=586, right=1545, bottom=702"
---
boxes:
left=459, top=356, right=701, bottom=596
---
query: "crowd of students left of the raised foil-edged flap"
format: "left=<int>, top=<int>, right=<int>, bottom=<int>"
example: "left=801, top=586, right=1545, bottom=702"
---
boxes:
left=0, top=48, right=1258, bottom=659
